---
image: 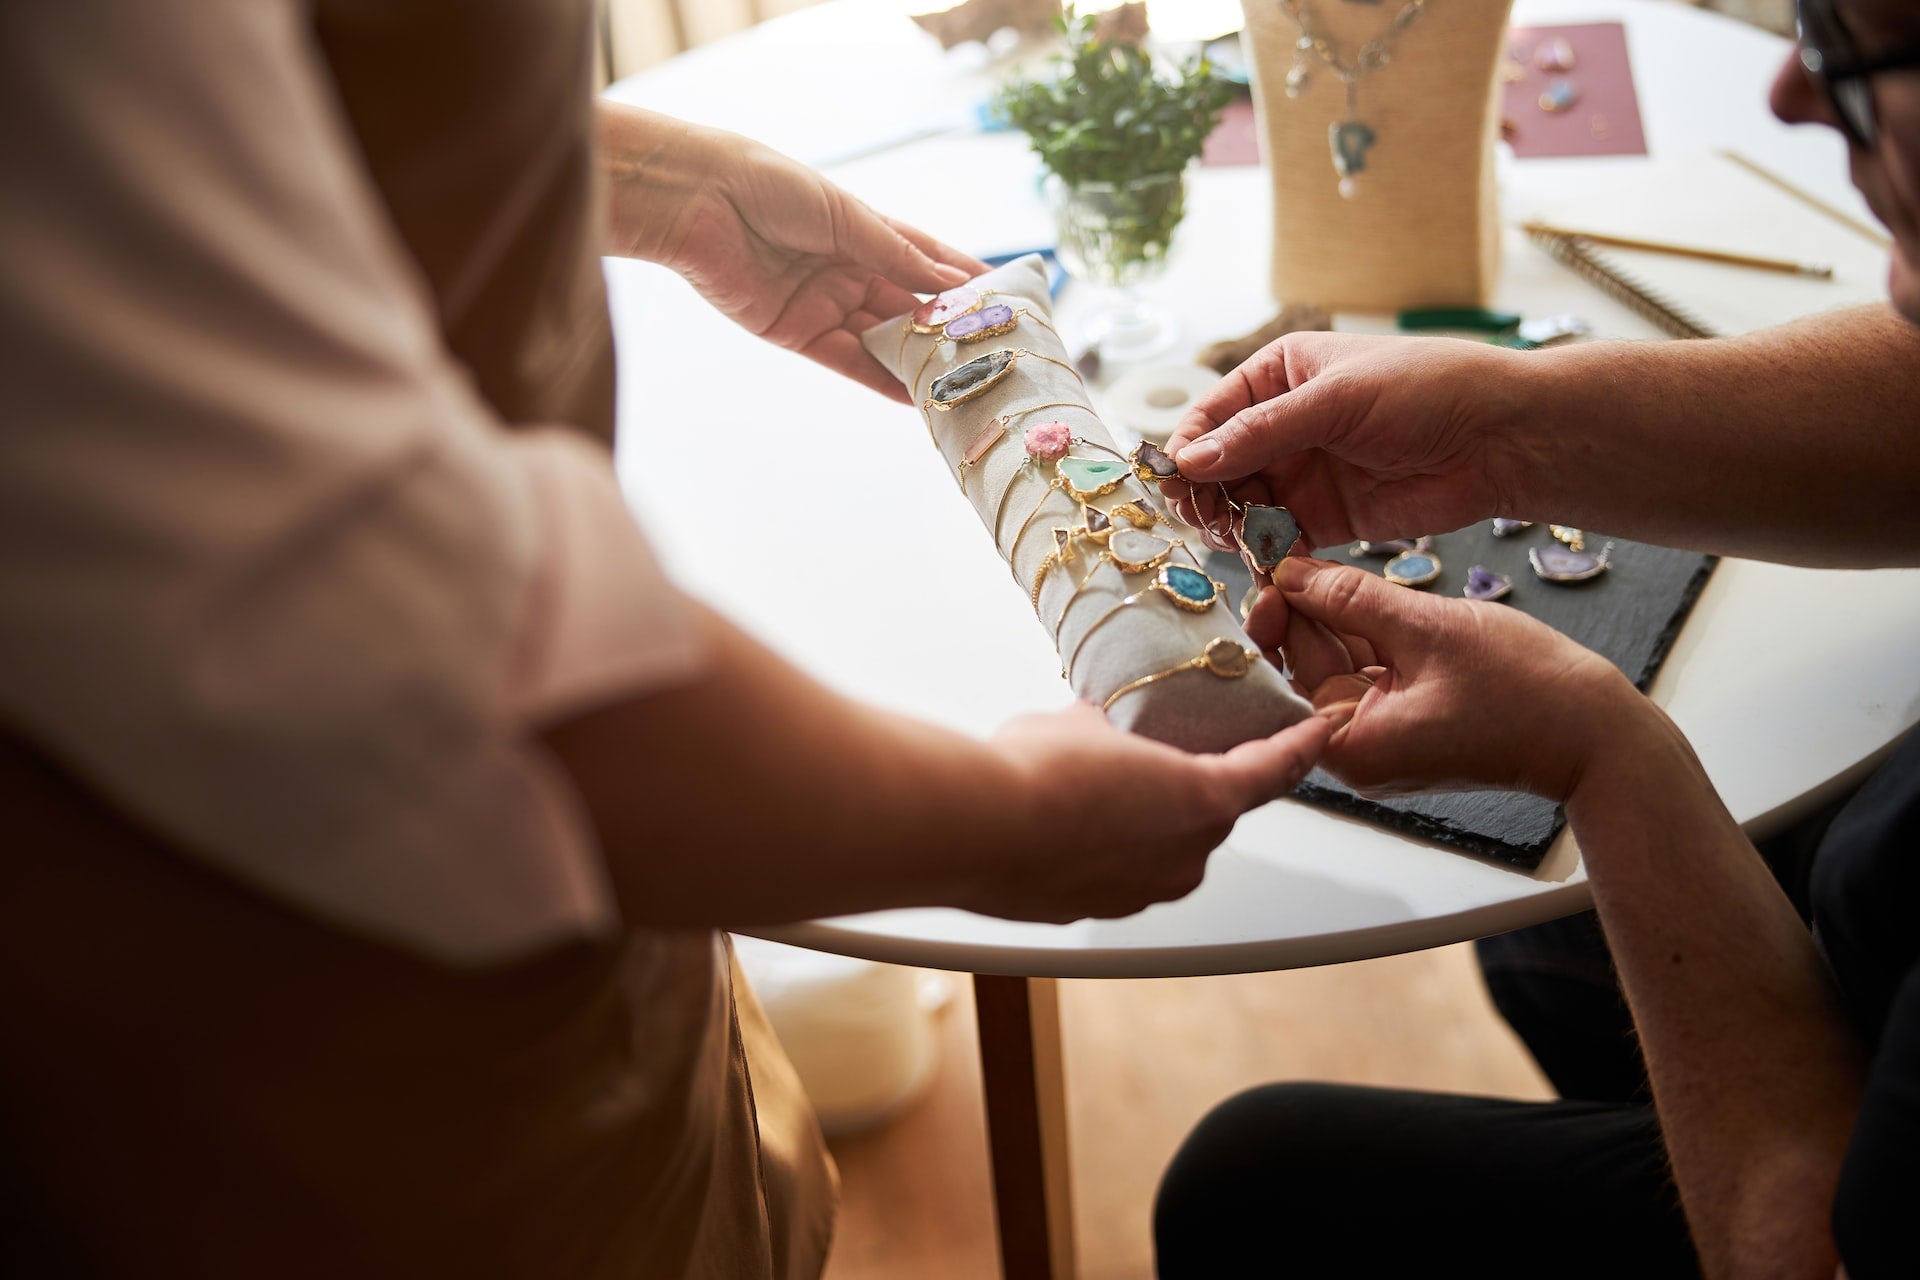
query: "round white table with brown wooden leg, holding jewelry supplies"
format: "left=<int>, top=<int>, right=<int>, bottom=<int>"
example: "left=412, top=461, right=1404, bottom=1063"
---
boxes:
left=609, top=0, right=1920, bottom=1274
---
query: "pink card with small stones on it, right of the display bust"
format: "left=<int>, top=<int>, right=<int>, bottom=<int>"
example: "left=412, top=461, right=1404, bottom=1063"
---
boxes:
left=1500, top=23, right=1647, bottom=157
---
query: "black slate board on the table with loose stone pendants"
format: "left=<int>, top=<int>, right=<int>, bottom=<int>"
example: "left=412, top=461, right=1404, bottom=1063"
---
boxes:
left=1208, top=520, right=1715, bottom=869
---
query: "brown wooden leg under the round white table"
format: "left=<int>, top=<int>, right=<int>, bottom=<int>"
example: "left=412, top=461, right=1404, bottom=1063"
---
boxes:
left=973, top=973, right=1075, bottom=1280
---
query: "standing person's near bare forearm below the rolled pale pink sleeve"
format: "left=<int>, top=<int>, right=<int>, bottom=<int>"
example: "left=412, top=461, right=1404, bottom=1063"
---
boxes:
left=545, top=614, right=1033, bottom=927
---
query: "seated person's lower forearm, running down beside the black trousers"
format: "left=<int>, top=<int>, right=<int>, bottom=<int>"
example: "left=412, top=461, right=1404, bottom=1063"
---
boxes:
left=1567, top=716, right=1864, bottom=1276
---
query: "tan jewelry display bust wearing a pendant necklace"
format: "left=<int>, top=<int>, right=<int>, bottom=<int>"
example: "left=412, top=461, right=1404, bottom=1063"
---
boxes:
left=1242, top=0, right=1511, bottom=311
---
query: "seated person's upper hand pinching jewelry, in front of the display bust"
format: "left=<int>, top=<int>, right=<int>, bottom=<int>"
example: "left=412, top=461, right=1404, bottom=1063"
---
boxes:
left=1165, top=332, right=1528, bottom=549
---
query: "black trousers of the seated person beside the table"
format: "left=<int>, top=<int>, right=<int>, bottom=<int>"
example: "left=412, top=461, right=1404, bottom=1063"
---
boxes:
left=1154, top=786, right=1839, bottom=1280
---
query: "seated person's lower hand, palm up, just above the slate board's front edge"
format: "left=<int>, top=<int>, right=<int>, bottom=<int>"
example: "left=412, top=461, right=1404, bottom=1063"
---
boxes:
left=1248, top=557, right=1665, bottom=800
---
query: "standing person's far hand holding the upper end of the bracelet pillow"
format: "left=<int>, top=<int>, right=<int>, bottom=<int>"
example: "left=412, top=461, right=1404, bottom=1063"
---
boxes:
left=601, top=102, right=987, bottom=403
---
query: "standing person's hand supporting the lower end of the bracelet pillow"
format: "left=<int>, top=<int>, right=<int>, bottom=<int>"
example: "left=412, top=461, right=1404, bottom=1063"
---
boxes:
left=964, top=702, right=1332, bottom=923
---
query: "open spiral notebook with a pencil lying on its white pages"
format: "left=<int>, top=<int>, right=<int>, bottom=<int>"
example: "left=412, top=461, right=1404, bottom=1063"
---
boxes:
left=1532, top=154, right=1887, bottom=338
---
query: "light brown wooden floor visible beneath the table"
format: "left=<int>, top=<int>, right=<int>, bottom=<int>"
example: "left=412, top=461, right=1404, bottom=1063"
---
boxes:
left=828, top=946, right=1551, bottom=1280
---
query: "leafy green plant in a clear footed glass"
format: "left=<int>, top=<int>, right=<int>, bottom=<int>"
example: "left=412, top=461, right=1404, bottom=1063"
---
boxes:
left=995, top=8, right=1233, bottom=355
